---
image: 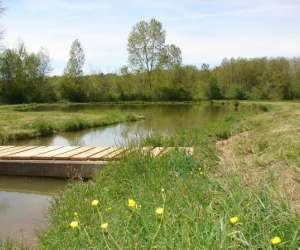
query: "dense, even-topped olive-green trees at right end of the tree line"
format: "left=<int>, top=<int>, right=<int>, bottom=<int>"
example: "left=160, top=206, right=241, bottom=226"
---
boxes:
left=213, top=58, right=300, bottom=100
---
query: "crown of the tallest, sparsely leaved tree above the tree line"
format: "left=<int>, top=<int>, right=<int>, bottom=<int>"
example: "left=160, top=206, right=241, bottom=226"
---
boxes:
left=127, top=19, right=166, bottom=72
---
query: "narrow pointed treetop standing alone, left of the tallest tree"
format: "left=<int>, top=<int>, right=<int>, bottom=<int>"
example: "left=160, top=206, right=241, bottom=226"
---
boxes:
left=65, top=39, right=85, bottom=78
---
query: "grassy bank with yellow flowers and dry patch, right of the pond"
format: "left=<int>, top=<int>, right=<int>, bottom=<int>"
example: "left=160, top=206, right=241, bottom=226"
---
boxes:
left=3, top=103, right=300, bottom=250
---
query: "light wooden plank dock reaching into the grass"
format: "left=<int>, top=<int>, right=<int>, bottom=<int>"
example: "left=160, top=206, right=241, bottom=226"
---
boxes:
left=0, top=146, right=193, bottom=178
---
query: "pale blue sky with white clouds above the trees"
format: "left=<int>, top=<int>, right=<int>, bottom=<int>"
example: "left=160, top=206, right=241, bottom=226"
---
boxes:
left=0, top=0, right=300, bottom=75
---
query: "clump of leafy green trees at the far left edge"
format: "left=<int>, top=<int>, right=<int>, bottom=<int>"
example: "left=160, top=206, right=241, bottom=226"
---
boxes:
left=0, top=43, right=56, bottom=103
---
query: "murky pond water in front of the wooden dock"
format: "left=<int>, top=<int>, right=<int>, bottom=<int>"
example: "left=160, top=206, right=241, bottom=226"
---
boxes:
left=0, top=176, right=66, bottom=244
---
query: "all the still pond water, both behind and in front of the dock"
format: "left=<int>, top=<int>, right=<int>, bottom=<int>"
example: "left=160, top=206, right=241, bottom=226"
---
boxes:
left=0, top=103, right=232, bottom=244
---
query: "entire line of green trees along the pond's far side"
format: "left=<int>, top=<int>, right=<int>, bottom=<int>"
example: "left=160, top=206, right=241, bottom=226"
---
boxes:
left=0, top=19, right=300, bottom=103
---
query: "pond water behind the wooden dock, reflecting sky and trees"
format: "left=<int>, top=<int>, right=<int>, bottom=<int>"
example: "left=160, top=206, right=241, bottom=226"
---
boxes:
left=15, top=103, right=230, bottom=146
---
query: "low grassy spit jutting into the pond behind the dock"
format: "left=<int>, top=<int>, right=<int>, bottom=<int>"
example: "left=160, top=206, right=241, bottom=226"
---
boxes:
left=0, top=105, right=142, bottom=144
